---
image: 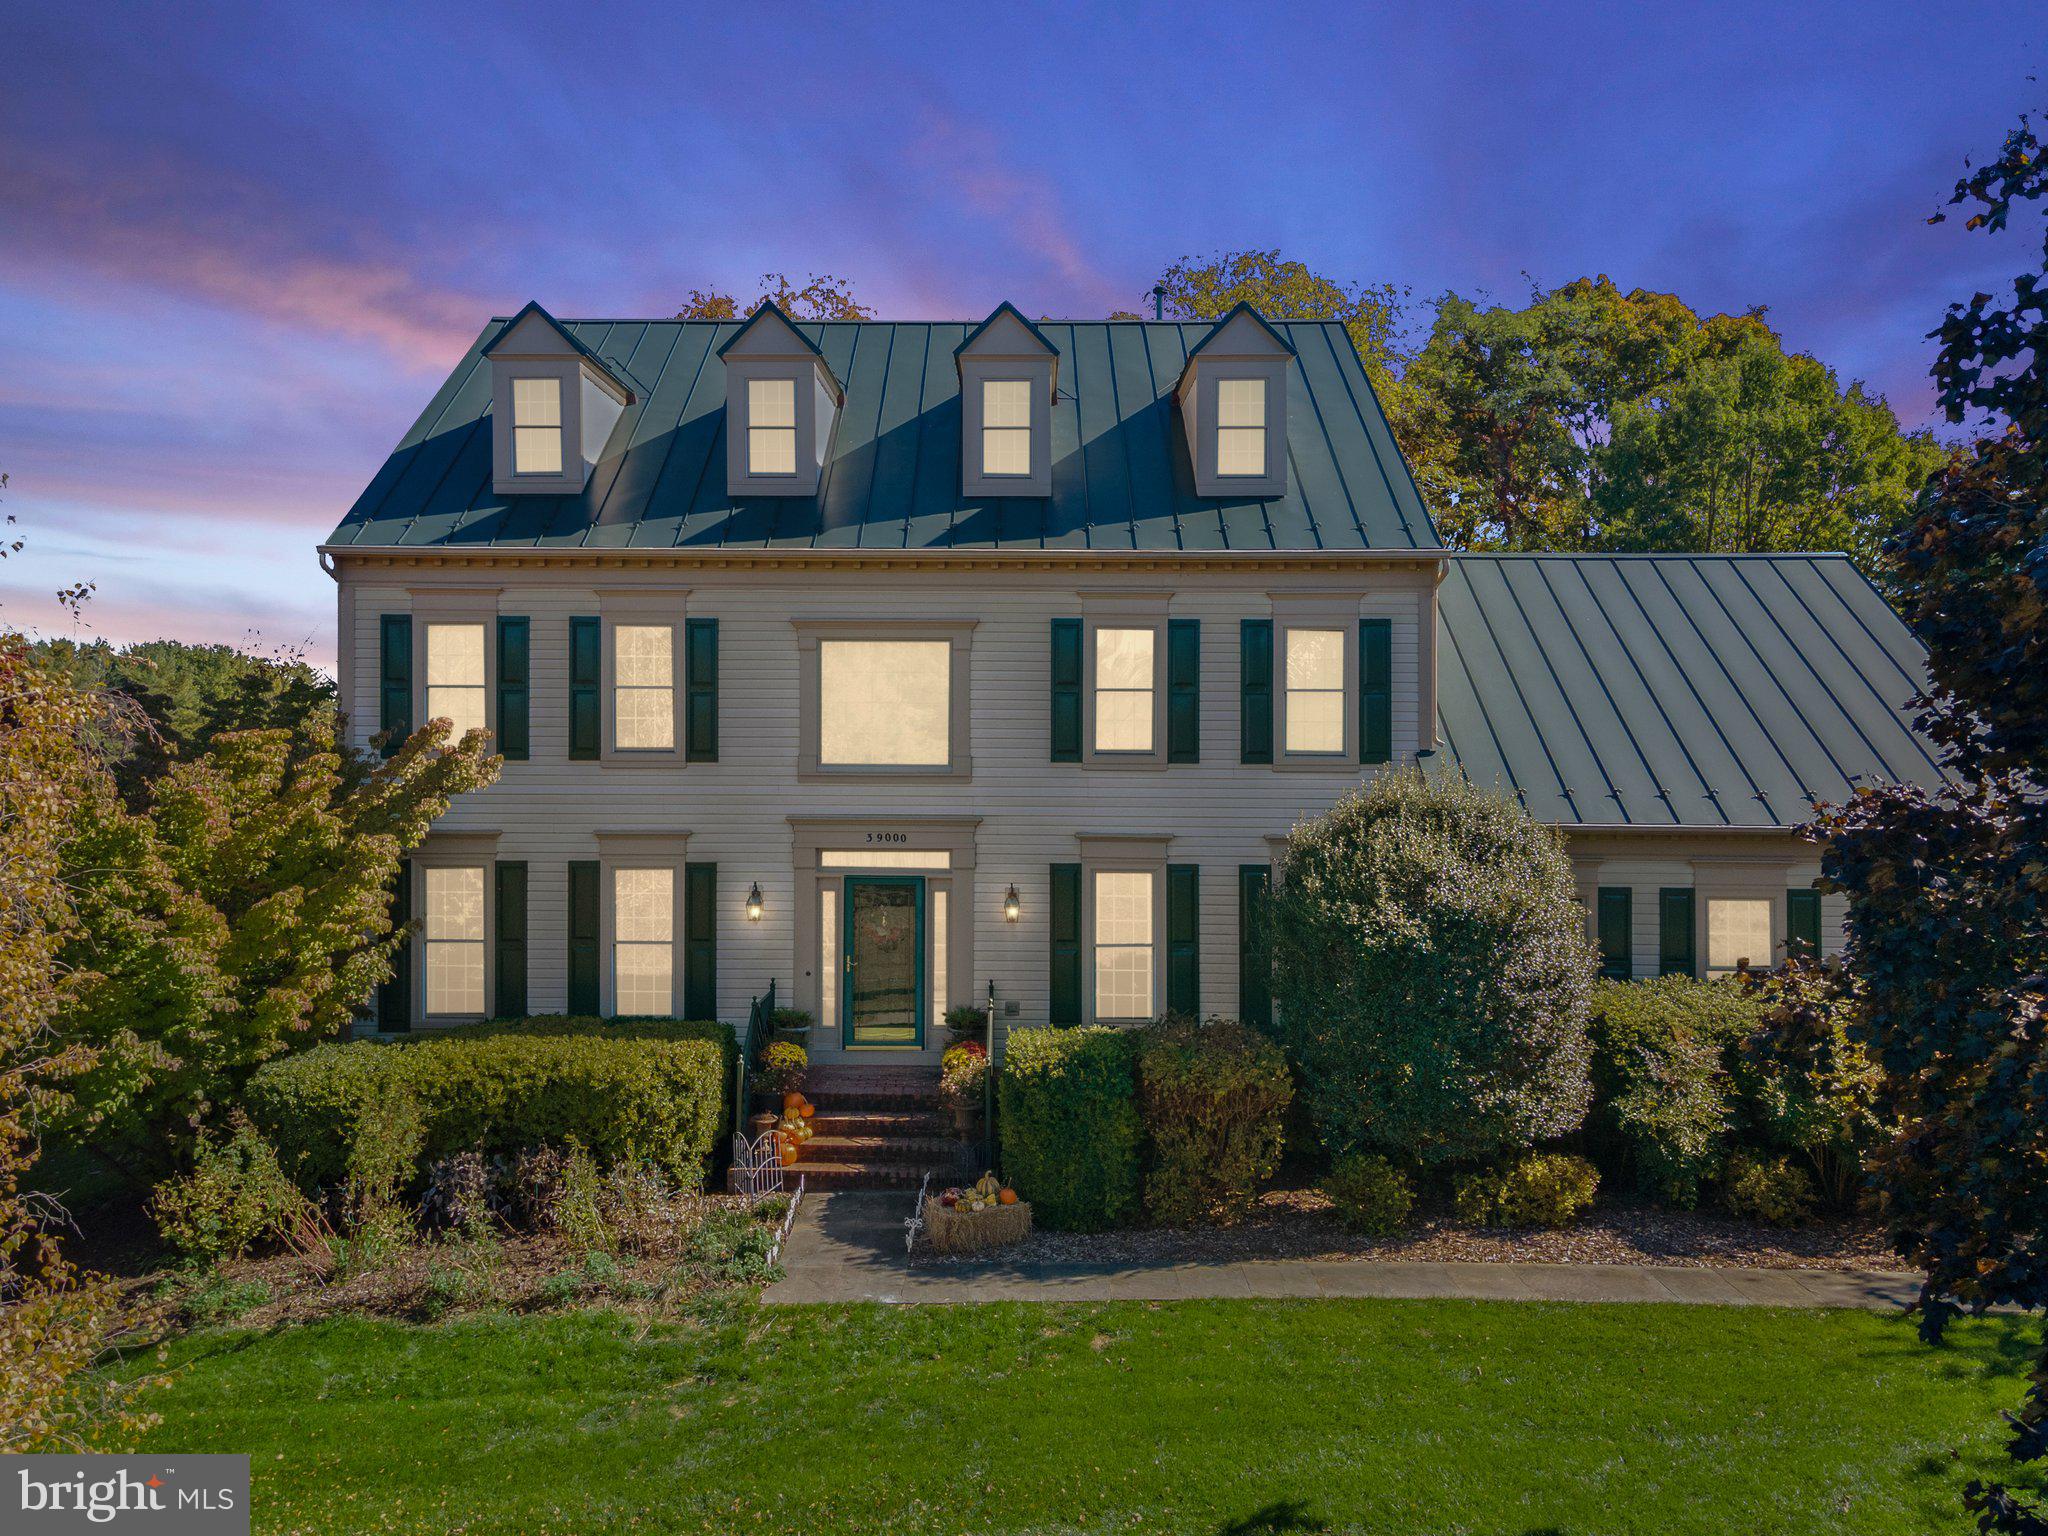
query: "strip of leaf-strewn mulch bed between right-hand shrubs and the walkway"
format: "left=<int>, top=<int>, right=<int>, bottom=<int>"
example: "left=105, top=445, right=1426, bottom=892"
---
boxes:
left=911, top=1188, right=1901, bottom=1270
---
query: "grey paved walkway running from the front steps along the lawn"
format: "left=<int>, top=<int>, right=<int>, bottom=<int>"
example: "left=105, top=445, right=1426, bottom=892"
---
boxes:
left=762, top=1190, right=1919, bottom=1311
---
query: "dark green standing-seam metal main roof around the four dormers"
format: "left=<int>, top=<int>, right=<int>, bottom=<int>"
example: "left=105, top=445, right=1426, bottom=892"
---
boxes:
left=328, top=319, right=1438, bottom=551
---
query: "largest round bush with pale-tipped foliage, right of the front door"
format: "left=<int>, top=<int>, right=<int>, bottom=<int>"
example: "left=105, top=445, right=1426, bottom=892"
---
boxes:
left=1270, top=772, right=1593, bottom=1165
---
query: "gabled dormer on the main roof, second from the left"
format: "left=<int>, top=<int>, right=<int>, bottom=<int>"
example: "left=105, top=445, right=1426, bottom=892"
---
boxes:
left=719, top=303, right=846, bottom=496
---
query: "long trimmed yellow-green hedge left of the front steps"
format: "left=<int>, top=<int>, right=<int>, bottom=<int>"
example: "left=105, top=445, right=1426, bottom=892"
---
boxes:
left=246, top=1014, right=735, bottom=1184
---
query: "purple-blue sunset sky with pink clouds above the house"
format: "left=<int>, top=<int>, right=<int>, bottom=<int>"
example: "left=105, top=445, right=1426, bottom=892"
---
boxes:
left=0, top=0, right=2048, bottom=662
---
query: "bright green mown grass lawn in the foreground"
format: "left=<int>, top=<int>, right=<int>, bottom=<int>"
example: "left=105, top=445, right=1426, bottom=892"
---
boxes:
left=136, top=1300, right=2034, bottom=1536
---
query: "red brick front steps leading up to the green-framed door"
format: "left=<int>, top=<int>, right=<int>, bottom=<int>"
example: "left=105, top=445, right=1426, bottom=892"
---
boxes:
left=737, top=1067, right=979, bottom=1190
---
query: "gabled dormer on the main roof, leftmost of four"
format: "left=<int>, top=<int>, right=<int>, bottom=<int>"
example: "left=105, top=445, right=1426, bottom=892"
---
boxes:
left=483, top=303, right=633, bottom=496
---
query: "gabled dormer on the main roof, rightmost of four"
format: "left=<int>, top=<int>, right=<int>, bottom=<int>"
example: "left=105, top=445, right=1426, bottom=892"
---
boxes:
left=1174, top=303, right=1294, bottom=498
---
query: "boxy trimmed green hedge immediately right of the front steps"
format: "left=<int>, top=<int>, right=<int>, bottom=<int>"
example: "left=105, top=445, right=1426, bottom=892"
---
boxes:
left=995, top=1026, right=1145, bottom=1233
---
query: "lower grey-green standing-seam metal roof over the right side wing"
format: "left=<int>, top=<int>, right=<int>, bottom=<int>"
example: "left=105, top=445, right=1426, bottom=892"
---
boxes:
left=1438, top=555, right=1942, bottom=827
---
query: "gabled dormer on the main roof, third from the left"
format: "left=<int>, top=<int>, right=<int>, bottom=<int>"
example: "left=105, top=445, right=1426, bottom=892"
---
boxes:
left=952, top=309, right=1059, bottom=496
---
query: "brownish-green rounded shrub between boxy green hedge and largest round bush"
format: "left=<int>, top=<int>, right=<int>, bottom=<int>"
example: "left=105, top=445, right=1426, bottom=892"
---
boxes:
left=1139, top=1018, right=1294, bottom=1227
